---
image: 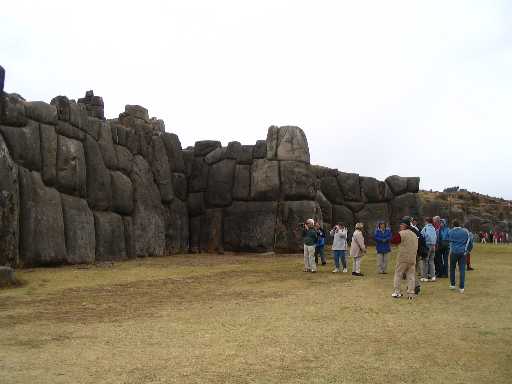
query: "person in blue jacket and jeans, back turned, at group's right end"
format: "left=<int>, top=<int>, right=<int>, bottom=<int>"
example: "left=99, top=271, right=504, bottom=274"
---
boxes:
left=449, top=220, right=473, bottom=293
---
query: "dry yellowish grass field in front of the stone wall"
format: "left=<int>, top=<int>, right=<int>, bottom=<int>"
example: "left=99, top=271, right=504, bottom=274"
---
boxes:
left=0, top=245, right=512, bottom=384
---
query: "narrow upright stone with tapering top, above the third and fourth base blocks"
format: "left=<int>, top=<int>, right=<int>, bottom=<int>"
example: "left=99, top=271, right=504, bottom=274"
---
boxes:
left=84, top=136, right=112, bottom=211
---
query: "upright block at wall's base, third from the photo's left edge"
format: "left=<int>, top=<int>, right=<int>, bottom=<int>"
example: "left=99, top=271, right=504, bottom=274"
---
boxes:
left=61, top=194, right=96, bottom=264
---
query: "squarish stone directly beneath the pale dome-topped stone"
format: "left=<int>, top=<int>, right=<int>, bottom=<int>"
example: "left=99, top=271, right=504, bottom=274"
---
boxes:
left=279, top=161, right=316, bottom=200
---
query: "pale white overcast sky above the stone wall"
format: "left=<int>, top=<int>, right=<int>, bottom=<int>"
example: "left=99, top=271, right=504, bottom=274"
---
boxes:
left=0, top=0, right=512, bottom=199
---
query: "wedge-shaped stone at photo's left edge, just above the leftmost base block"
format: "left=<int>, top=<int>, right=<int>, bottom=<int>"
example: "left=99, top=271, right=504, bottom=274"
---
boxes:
left=0, top=120, right=41, bottom=171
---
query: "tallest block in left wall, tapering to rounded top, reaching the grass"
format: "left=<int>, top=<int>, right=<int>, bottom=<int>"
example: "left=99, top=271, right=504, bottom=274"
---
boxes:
left=130, top=155, right=165, bottom=257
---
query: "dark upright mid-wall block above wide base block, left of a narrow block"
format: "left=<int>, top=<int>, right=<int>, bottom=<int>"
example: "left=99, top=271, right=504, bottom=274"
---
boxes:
left=205, top=159, right=236, bottom=207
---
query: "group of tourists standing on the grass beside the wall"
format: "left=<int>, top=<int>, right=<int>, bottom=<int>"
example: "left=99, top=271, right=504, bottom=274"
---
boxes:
left=303, top=216, right=473, bottom=299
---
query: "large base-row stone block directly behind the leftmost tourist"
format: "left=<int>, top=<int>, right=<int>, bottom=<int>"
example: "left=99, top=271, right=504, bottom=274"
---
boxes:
left=274, top=201, right=323, bottom=252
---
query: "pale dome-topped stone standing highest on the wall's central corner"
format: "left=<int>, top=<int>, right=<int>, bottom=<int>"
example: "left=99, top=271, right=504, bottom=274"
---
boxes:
left=277, top=126, right=309, bottom=164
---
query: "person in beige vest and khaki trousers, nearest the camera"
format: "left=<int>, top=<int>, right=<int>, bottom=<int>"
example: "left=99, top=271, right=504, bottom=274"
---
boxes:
left=391, top=218, right=418, bottom=299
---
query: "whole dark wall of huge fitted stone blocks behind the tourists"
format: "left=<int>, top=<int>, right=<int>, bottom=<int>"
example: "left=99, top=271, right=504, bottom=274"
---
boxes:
left=0, top=67, right=419, bottom=267
